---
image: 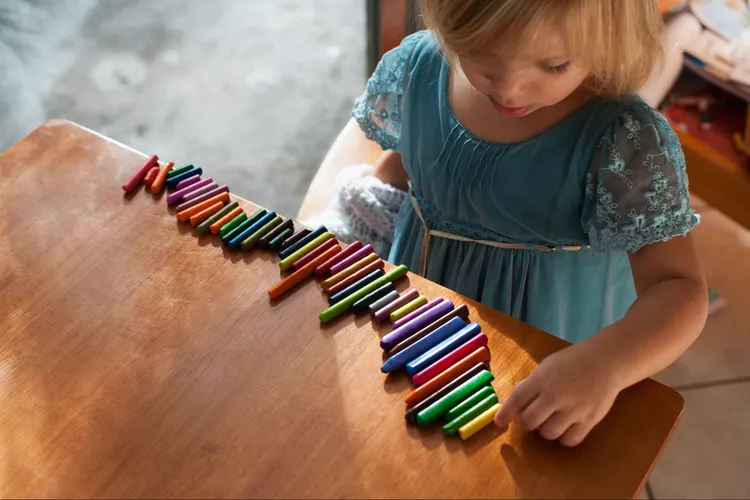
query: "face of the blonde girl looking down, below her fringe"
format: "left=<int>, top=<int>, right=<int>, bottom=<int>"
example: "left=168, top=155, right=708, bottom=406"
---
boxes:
left=459, top=36, right=589, bottom=117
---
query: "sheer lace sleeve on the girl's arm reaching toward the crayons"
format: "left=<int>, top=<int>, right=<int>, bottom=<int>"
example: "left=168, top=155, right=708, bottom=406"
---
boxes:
left=582, top=106, right=699, bottom=252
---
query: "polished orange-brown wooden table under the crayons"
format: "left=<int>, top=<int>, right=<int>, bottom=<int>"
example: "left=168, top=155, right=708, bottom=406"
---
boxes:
left=0, top=120, right=683, bottom=498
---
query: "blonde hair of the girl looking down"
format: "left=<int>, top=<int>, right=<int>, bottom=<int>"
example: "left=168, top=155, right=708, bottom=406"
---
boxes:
left=420, top=0, right=664, bottom=96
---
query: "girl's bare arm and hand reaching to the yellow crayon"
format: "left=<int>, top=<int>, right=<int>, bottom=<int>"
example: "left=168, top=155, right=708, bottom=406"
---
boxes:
left=496, top=235, right=708, bottom=446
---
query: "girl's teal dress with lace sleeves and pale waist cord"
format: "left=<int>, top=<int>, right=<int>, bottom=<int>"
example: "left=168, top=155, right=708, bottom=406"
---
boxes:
left=353, top=32, right=698, bottom=342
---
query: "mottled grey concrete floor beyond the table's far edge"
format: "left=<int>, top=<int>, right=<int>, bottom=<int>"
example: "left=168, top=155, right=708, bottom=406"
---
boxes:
left=0, top=0, right=365, bottom=215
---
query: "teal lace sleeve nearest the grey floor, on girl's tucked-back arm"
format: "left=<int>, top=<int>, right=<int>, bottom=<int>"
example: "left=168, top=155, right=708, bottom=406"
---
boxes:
left=352, top=32, right=425, bottom=151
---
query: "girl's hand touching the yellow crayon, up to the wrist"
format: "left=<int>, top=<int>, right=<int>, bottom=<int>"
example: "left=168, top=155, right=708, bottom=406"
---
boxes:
left=495, top=344, right=623, bottom=446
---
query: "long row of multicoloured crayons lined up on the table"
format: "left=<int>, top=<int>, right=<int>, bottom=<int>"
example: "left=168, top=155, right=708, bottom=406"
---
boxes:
left=123, top=156, right=500, bottom=439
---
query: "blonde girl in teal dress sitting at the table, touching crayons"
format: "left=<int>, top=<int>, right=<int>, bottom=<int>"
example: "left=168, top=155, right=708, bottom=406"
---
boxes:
left=302, top=0, right=708, bottom=446
